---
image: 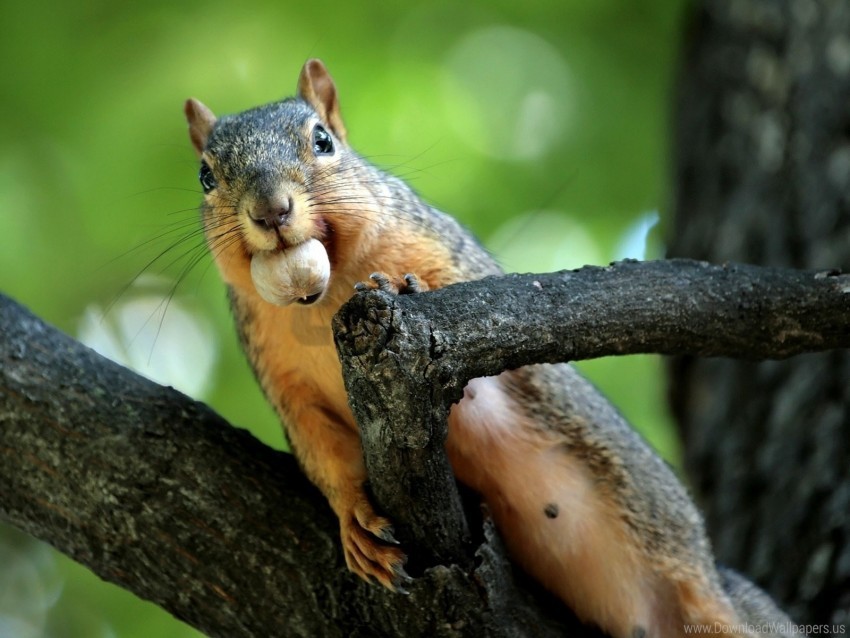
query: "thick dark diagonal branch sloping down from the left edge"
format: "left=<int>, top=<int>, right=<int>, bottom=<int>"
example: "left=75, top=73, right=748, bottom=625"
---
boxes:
left=0, top=296, right=576, bottom=638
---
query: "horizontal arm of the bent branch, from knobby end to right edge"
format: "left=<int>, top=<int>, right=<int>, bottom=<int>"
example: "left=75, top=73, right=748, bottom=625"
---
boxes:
left=335, top=259, right=850, bottom=410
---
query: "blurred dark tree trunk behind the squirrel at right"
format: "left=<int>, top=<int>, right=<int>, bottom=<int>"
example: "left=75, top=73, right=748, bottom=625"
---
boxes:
left=670, top=0, right=850, bottom=623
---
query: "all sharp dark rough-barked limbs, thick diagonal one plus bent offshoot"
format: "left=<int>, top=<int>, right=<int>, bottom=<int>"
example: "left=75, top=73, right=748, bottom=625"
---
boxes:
left=0, top=254, right=850, bottom=636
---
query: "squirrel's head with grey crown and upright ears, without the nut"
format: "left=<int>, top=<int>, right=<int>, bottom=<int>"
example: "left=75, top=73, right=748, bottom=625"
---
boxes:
left=184, top=59, right=362, bottom=298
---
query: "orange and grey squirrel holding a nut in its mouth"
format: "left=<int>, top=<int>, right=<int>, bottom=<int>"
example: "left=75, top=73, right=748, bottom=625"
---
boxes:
left=184, top=59, right=792, bottom=638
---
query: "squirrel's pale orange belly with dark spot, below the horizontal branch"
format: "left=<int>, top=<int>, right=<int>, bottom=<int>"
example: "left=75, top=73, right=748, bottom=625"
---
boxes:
left=447, top=377, right=678, bottom=636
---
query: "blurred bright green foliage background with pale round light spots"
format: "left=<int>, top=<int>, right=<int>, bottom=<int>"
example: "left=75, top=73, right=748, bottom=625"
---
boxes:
left=0, top=0, right=685, bottom=638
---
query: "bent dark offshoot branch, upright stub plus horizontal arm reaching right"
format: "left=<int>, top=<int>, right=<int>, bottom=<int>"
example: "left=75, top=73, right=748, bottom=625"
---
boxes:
left=334, top=260, right=850, bottom=576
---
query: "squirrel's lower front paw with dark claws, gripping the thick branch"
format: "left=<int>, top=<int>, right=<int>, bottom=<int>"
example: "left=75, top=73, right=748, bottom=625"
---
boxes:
left=340, top=500, right=411, bottom=594
